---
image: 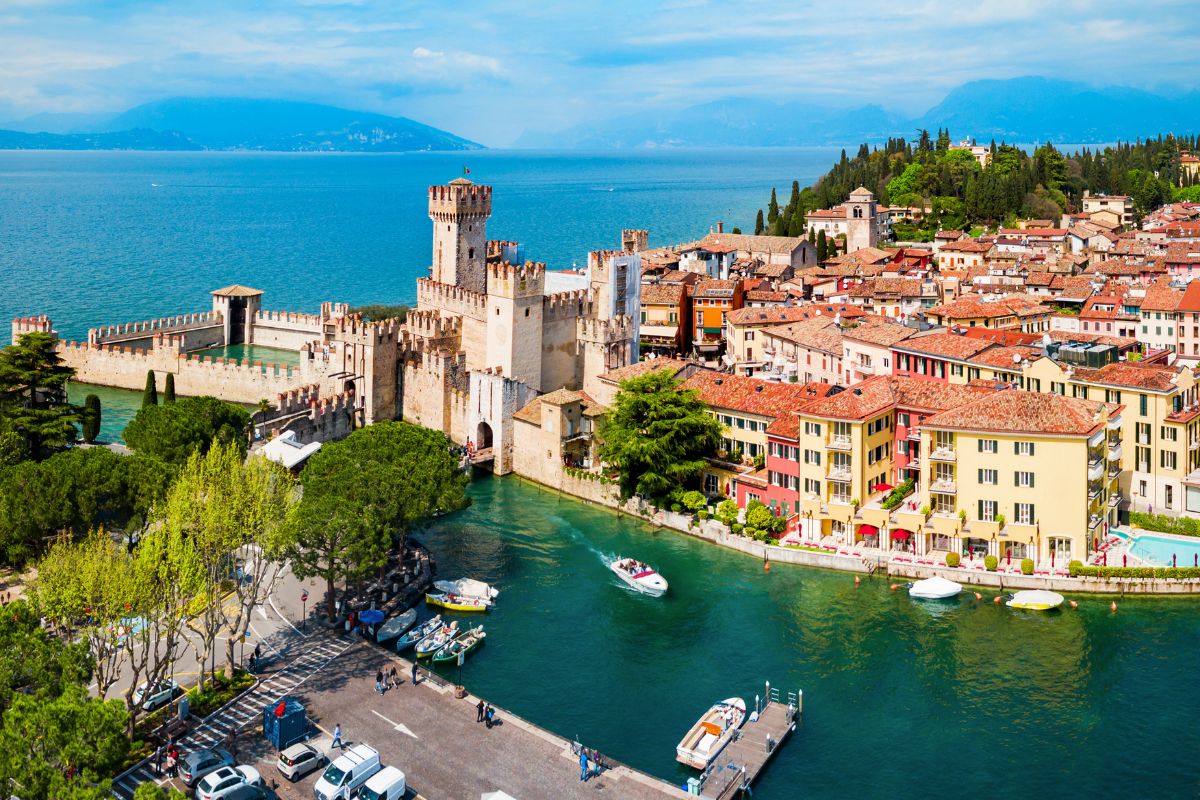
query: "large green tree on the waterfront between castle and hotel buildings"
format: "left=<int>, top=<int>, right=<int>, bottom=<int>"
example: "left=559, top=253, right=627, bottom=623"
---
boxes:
left=600, top=369, right=722, bottom=499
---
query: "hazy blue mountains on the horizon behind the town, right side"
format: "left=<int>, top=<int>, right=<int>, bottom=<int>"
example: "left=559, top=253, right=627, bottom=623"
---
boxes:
left=517, top=77, right=1200, bottom=150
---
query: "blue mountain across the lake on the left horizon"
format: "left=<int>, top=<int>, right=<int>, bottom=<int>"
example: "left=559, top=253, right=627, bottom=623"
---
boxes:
left=0, top=97, right=482, bottom=152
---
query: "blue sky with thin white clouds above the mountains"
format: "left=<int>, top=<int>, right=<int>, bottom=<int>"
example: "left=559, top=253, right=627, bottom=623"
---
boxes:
left=0, top=0, right=1200, bottom=146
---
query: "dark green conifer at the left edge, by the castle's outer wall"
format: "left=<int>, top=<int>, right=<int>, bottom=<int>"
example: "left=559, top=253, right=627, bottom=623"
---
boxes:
left=0, top=331, right=79, bottom=458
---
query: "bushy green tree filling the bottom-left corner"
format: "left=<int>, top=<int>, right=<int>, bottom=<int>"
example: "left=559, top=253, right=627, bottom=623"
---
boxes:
left=0, top=685, right=130, bottom=800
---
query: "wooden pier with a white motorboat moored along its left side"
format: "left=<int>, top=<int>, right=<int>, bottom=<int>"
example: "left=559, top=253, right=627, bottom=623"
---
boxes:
left=700, top=684, right=804, bottom=800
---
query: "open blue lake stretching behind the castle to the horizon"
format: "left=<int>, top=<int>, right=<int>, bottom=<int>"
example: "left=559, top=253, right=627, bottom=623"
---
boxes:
left=0, top=148, right=839, bottom=339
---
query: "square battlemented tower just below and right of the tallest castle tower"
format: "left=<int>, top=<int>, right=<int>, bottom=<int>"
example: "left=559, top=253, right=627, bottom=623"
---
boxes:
left=485, top=263, right=547, bottom=391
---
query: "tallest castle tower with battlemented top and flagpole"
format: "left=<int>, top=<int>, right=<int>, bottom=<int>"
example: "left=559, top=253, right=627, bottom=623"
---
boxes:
left=430, top=178, right=492, bottom=294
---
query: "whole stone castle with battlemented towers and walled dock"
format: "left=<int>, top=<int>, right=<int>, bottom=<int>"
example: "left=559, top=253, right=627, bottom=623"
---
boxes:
left=12, top=179, right=647, bottom=474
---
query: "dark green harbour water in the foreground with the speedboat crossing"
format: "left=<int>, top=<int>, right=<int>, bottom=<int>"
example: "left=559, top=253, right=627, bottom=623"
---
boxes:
left=421, top=479, right=1200, bottom=800
